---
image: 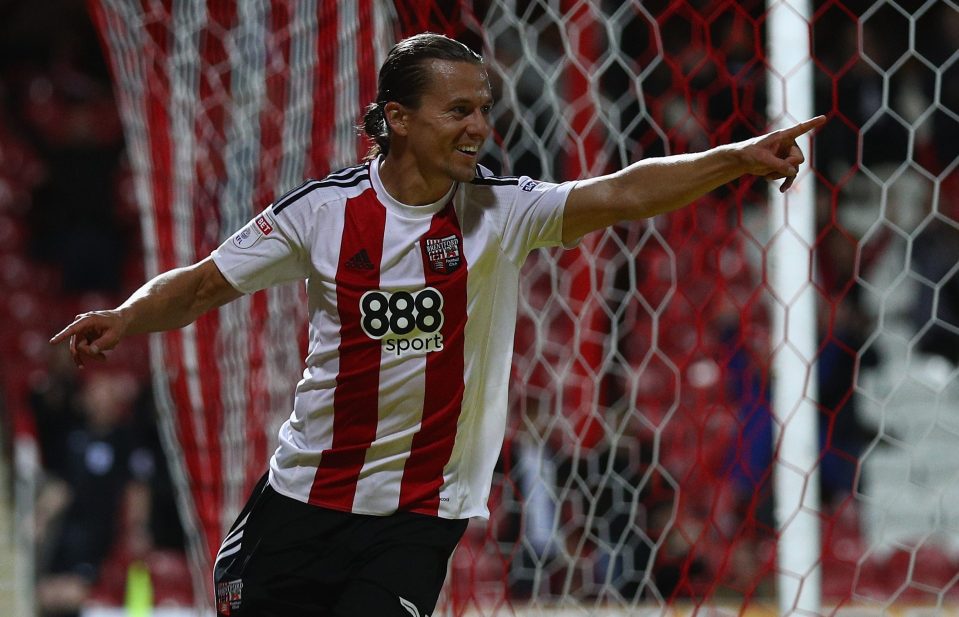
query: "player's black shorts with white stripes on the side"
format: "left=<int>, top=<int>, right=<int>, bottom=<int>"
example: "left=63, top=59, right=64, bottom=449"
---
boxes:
left=213, top=476, right=468, bottom=617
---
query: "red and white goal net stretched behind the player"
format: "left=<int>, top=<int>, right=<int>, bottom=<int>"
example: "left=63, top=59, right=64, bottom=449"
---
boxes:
left=90, top=0, right=959, bottom=615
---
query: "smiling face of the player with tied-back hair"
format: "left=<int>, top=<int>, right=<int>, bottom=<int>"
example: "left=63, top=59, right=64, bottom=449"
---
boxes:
left=394, top=60, right=493, bottom=183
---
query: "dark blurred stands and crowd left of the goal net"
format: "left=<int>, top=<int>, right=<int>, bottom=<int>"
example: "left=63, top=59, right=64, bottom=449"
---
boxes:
left=0, top=0, right=192, bottom=616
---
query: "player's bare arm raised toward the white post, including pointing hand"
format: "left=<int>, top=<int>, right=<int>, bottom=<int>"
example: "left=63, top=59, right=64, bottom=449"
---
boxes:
left=563, top=116, right=826, bottom=243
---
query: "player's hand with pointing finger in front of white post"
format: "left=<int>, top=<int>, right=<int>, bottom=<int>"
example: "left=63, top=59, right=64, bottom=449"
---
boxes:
left=736, top=116, right=826, bottom=193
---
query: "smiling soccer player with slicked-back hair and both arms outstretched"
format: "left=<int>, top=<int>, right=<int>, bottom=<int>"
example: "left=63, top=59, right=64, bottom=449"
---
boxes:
left=51, top=33, right=825, bottom=617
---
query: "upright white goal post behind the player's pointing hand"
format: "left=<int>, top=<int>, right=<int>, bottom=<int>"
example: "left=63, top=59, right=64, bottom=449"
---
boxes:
left=766, top=0, right=822, bottom=615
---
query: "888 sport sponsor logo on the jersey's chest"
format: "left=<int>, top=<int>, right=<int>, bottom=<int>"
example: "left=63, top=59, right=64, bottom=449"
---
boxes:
left=360, top=287, right=443, bottom=356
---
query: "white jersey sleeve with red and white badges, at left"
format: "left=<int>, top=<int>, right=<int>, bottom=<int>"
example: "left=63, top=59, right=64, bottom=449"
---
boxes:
left=212, top=200, right=309, bottom=293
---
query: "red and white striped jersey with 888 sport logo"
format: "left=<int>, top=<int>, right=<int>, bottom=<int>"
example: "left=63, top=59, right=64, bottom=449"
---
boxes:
left=213, top=160, right=573, bottom=518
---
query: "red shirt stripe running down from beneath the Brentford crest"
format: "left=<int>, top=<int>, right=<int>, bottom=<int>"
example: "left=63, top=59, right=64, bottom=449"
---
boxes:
left=399, top=199, right=468, bottom=516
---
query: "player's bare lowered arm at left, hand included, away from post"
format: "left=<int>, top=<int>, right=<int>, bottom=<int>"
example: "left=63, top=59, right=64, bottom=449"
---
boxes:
left=50, top=257, right=243, bottom=367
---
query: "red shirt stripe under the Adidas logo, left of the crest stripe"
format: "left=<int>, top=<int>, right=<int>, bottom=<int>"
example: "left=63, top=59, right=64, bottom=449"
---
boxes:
left=309, top=189, right=386, bottom=511
